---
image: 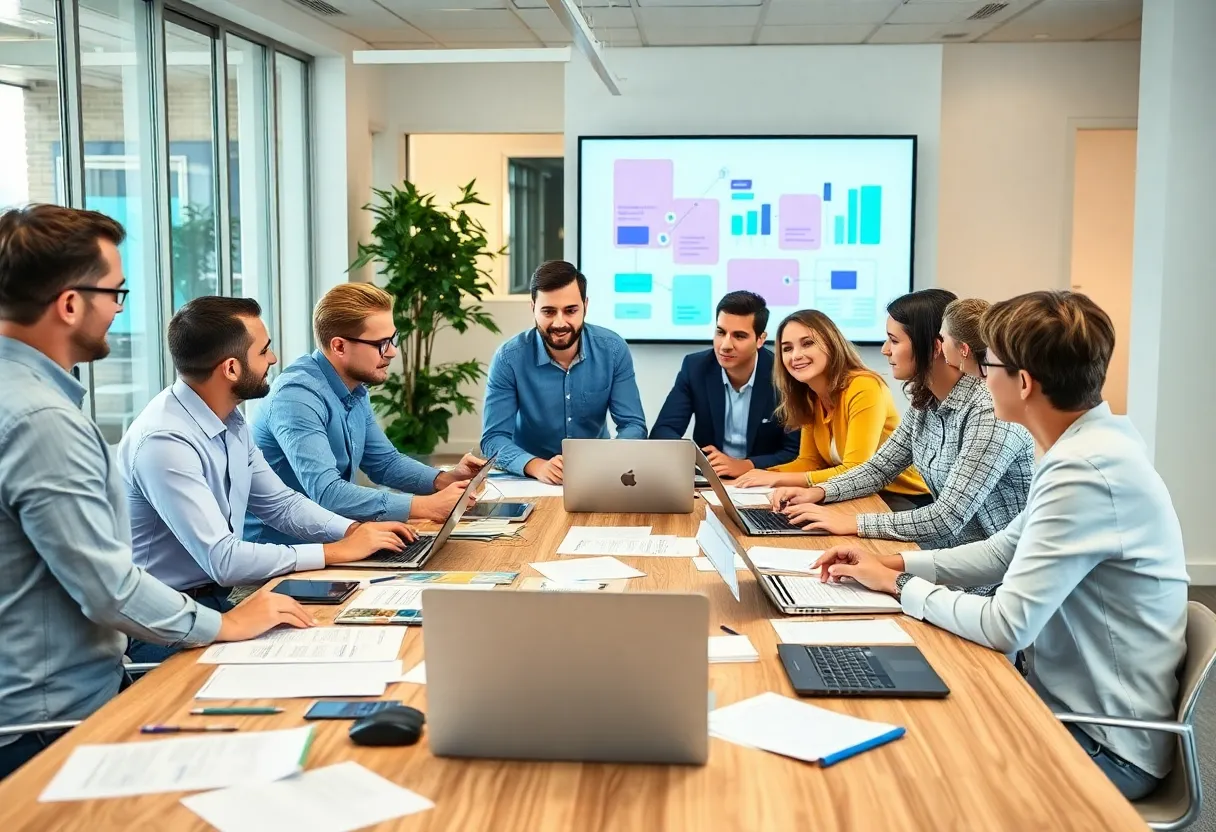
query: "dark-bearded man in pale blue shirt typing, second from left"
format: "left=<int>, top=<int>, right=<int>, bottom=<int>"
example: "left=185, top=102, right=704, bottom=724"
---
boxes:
left=118, top=297, right=416, bottom=662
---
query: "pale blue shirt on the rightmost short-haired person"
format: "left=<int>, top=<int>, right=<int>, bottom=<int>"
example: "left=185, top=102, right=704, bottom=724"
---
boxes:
left=900, top=404, right=1188, bottom=777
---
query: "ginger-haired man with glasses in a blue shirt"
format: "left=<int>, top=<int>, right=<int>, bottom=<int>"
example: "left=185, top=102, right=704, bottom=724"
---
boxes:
left=246, top=283, right=484, bottom=543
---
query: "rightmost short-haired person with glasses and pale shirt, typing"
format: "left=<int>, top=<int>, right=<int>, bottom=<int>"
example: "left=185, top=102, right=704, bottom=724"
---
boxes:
left=820, top=292, right=1188, bottom=799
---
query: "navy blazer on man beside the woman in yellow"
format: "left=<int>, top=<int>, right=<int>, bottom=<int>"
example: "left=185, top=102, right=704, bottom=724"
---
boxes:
left=651, top=349, right=801, bottom=468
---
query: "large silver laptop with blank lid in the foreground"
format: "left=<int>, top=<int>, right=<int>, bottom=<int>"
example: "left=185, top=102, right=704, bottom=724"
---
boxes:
left=422, top=588, right=709, bottom=765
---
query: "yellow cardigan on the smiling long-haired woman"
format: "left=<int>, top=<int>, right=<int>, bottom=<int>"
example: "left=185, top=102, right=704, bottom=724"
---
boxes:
left=771, top=373, right=929, bottom=494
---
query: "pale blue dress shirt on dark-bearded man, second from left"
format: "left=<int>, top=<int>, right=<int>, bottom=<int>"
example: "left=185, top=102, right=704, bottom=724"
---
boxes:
left=118, top=378, right=351, bottom=589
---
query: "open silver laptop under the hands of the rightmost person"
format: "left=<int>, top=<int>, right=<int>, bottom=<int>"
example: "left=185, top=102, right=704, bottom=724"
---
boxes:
left=697, top=501, right=901, bottom=615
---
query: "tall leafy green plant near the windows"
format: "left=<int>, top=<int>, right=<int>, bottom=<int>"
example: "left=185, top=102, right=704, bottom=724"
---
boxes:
left=350, top=181, right=506, bottom=456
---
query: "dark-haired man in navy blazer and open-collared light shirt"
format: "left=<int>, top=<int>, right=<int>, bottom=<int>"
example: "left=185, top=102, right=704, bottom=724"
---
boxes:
left=651, top=292, right=799, bottom=477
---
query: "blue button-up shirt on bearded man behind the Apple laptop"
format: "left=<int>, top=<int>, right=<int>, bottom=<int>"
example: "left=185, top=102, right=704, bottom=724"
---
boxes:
left=482, top=324, right=646, bottom=476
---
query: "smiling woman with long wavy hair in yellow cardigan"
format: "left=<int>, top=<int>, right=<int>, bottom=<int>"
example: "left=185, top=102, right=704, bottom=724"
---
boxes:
left=734, top=309, right=933, bottom=511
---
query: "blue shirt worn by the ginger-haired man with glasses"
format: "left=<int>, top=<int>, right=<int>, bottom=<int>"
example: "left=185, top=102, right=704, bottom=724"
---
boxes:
left=244, top=350, right=439, bottom=543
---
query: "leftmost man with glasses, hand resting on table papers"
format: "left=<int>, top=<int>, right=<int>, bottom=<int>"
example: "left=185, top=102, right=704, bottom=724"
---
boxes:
left=0, top=204, right=313, bottom=780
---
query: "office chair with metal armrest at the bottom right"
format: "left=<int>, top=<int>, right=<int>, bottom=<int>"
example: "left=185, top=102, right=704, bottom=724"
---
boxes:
left=1055, top=601, right=1216, bottom=832
